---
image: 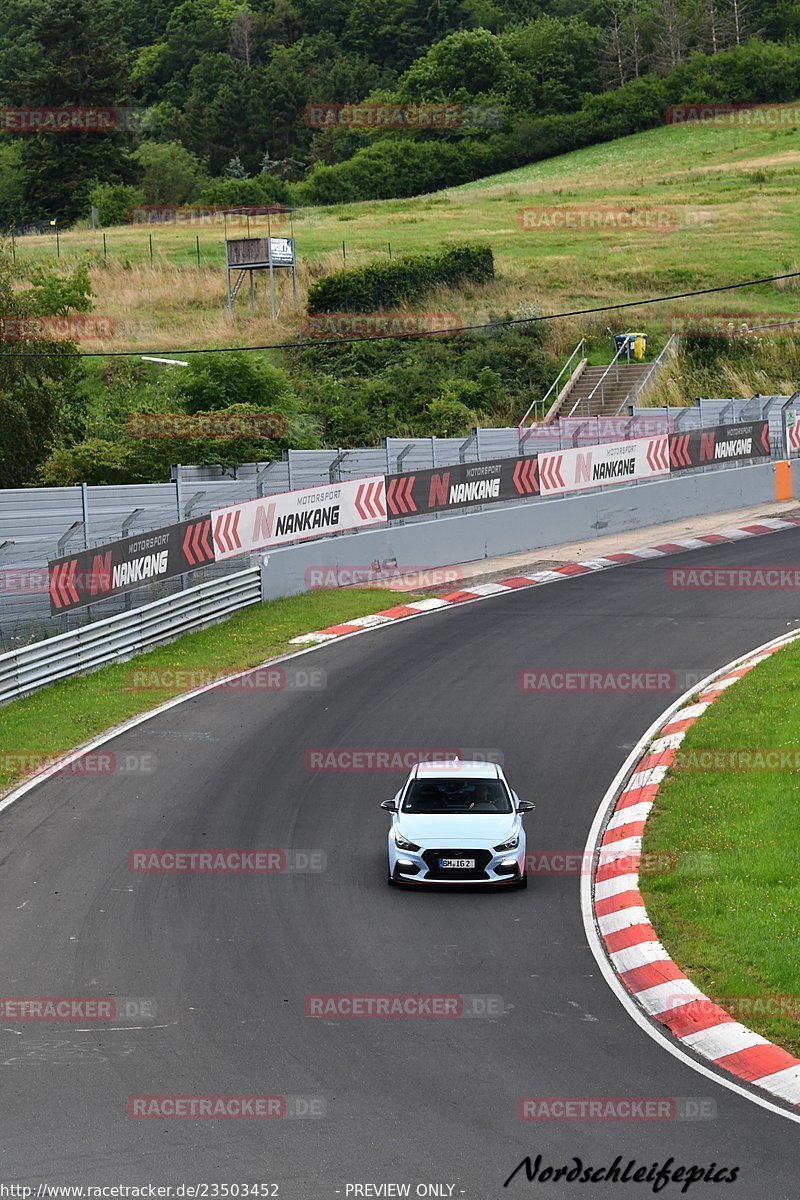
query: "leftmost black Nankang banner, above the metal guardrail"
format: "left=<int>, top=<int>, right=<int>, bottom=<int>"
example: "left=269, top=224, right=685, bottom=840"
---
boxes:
left=47, top=516, right=213, bottom=613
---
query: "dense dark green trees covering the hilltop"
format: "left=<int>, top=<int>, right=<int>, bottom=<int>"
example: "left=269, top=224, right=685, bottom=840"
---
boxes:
left=0, top=0, right=800, bottom=228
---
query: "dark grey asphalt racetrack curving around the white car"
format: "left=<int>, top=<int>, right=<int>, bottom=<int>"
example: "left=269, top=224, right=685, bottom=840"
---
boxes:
left=0, top=530, right=800, bottom=1200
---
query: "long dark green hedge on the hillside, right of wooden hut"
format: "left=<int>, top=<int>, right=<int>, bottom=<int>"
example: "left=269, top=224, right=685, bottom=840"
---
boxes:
left=308, top=242, right=494, bottom=313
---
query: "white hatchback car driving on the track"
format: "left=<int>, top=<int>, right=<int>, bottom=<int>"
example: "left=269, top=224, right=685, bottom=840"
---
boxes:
left=380, top=760, right=534, bottom=888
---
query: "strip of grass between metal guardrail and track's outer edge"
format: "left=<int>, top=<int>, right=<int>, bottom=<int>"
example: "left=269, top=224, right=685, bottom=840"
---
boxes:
left=0, top=588, right=423, bottom=796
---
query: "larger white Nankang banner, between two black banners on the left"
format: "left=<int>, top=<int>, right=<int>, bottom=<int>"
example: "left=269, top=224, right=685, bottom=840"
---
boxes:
left=211, top=475, right=386, bottom=563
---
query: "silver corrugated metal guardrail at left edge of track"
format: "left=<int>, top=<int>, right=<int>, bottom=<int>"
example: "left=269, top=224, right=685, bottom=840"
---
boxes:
left=0, top=566, right=261, bottom=703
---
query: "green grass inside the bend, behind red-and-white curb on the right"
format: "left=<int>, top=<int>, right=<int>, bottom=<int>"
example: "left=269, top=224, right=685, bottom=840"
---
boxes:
left=640, top=642, right=800, bottom=1055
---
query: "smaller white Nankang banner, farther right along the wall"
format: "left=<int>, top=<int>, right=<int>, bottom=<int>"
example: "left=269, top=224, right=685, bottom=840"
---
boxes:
left=539, top=434, right=669, bottom=496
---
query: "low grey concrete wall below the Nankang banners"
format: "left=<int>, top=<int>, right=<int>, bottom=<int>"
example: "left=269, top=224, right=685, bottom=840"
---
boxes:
left=260, top=460, right=800, bottom=600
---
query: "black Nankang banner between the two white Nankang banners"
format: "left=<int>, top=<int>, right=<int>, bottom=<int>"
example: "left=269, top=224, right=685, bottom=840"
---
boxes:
left=386, top=455, right=539, bottom=518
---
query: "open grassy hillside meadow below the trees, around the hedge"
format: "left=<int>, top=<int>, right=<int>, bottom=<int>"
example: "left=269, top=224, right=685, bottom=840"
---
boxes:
left=7, top=112, right=800, bottom=349
